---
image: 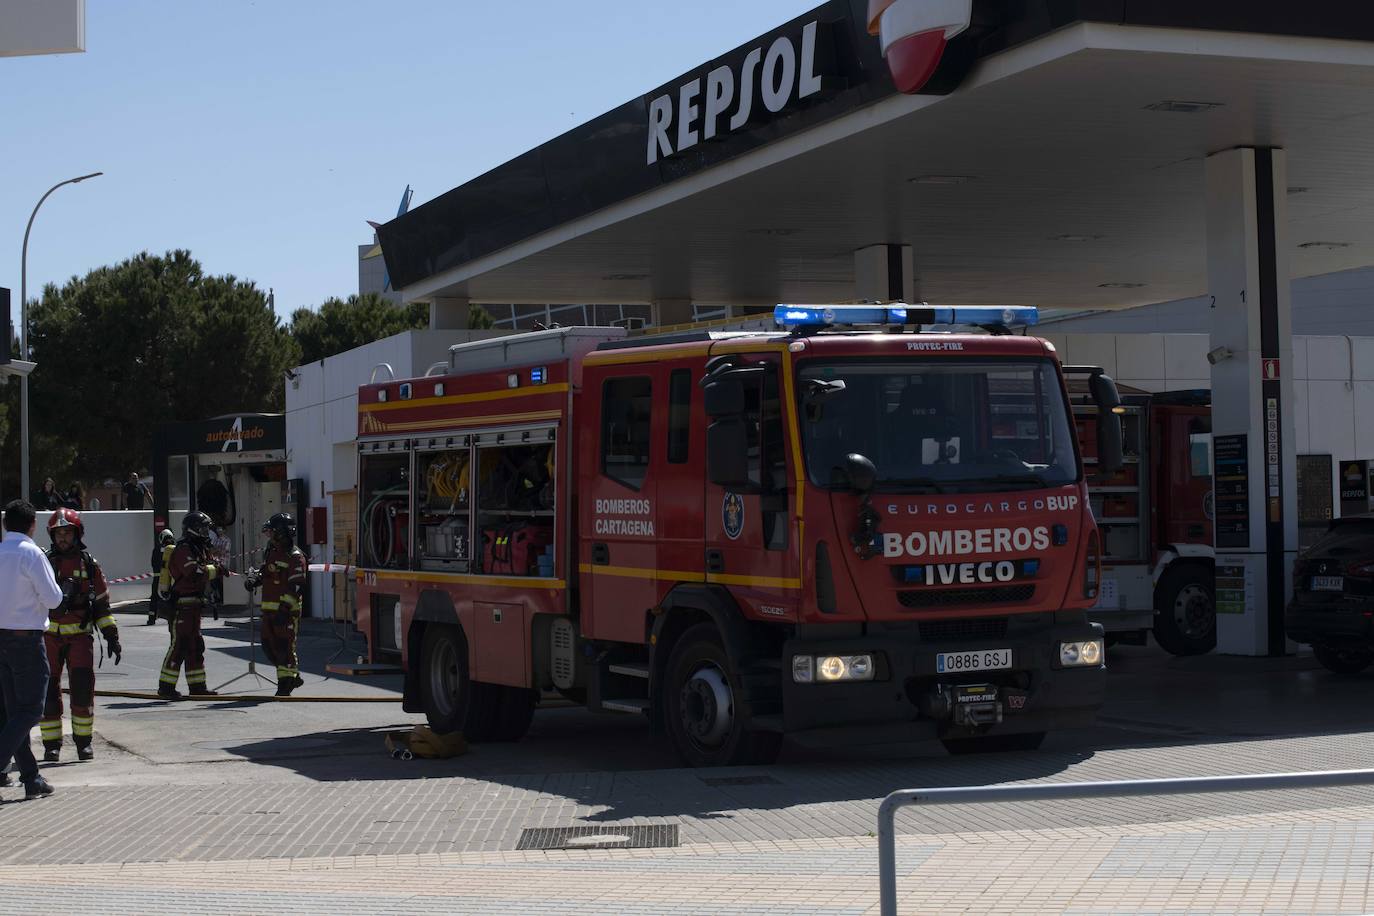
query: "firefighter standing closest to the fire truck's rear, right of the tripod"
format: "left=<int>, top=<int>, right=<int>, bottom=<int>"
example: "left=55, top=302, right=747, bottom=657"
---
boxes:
left=247, top=512, right=306, bottom=696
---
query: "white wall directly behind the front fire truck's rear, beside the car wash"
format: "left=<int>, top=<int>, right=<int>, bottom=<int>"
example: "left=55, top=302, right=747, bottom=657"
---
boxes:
left=286, top=330, right=506, bottom=617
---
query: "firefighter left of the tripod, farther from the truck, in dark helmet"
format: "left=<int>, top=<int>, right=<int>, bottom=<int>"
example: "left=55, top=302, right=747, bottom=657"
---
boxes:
left=158, top=512, right=220, bottom=700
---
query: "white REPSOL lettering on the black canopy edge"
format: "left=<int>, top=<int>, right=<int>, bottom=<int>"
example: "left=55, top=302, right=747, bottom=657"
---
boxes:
left=647, top=19, right=835, bottom=165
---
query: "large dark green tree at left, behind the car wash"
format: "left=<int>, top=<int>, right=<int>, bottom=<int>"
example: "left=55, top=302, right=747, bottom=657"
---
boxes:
left=18, top=243, right=300, bottom=481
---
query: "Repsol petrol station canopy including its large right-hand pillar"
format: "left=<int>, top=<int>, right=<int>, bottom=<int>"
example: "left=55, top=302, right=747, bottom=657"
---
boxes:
left=360, top=0, right=1374, bottom=655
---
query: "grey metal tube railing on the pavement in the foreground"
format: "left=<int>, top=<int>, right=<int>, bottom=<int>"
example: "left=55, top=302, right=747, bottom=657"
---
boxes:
left=878, top=769, right=1374, bottom=916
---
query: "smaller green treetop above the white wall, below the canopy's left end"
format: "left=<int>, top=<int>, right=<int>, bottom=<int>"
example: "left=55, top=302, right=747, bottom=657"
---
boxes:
left=290, top=293, right=492, bottom=364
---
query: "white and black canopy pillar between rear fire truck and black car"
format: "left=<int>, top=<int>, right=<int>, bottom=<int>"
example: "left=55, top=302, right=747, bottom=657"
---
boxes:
left=1206, top=148, right=1297, bottom=655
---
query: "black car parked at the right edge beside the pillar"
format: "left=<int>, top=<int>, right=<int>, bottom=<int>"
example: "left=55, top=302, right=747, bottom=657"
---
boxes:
left=1283, top=515, right=1374, bottom=674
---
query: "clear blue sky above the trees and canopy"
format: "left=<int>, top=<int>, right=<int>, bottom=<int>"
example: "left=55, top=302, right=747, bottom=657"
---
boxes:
left=0, top=0, right=819, bottom=319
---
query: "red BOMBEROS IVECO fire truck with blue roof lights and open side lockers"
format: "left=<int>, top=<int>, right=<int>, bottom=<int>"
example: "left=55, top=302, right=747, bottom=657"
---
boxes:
left=357, top=306, right=1121, bottom=766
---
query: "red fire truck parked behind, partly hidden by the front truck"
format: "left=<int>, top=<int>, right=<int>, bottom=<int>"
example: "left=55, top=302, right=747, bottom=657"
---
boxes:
left=1070, top=386, right=1216, bottom=655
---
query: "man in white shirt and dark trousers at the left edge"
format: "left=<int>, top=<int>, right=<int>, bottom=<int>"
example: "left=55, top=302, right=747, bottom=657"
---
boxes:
left=0, top=500, right=66, bottom=798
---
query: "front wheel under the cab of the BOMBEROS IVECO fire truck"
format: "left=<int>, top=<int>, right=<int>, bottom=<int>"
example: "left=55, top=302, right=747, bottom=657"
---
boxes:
left=662, top=623, right=782, bottom=766
